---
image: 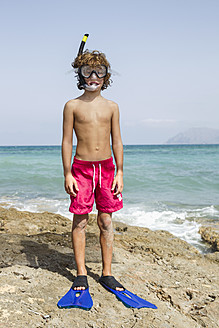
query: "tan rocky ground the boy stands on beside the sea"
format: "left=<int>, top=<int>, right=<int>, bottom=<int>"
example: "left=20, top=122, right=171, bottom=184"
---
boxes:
left=0, top=208, right=219, bottom=328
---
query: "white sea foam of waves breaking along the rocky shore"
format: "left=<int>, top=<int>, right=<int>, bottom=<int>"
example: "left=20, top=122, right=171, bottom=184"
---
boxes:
left=0, top=195, right=219, bottom=252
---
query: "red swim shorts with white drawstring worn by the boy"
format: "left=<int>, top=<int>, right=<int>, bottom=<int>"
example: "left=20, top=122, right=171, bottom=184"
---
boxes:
left=69, top=157, right=123, bottom=214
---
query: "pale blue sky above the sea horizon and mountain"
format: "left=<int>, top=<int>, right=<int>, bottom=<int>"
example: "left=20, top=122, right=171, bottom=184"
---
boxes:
left=0, top=0, right=219, bottom=145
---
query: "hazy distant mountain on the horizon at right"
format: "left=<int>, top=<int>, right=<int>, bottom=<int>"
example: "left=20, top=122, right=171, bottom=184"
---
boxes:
left=166, top=128, right=219, bottom=144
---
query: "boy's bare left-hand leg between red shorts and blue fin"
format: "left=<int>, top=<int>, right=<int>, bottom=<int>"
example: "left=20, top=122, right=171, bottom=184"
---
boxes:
left=72, top=214, right=88, bottom=290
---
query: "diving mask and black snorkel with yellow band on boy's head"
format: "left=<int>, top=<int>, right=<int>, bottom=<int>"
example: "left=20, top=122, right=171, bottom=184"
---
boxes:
left=72, top=34, right=108, bottom=91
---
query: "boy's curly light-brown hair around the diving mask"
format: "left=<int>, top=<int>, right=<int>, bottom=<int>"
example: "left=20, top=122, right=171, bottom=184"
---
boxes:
left=71, top=50, right=112, bottom=90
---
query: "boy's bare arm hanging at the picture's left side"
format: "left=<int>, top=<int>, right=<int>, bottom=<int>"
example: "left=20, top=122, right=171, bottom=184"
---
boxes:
left=62, top=102, right=79, bottom=197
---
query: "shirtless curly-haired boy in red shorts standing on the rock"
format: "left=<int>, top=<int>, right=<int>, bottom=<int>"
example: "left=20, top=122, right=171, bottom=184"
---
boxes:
left=62, top=37, right=123, bottom=296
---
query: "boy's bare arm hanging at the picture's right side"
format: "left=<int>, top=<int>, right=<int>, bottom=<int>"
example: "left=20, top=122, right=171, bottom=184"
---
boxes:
left=111, top=104, right=123, bottom=195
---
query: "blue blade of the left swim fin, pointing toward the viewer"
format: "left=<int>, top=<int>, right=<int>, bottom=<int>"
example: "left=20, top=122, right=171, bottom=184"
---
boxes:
left=57, top=288, right=93, bottom=310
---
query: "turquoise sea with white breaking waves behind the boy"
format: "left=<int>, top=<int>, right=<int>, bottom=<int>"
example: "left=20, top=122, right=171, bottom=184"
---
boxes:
left=0, top=145, right=219, bottom=253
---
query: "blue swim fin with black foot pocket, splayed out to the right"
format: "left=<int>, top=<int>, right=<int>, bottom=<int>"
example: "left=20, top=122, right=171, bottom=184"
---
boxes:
left=99, top=278, right=157, bottom=309
